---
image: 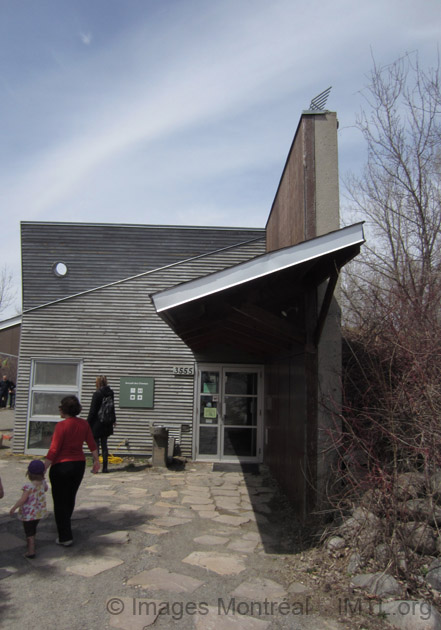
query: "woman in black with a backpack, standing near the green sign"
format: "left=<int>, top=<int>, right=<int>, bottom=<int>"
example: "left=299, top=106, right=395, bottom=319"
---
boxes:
left=87, top=376, right=116, bottom=473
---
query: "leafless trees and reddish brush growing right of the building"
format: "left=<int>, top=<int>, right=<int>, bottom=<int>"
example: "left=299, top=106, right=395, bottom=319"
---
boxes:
left=326, top=54, right=441, bottom=588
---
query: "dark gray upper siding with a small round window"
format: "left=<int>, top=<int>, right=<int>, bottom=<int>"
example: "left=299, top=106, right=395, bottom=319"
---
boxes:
left=21, top=222, right=265, bottom=310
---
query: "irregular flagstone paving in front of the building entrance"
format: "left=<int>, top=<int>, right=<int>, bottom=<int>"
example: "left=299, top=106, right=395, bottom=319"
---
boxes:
left=0, top=444, right=334, bottom=630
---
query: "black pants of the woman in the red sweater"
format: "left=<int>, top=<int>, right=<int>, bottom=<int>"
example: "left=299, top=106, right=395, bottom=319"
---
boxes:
left=49, top=461, right=86, bottom=542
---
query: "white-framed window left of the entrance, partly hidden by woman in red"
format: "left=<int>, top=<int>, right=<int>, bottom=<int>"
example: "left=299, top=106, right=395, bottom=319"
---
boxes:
left=26, top=359, right=82, bottom=454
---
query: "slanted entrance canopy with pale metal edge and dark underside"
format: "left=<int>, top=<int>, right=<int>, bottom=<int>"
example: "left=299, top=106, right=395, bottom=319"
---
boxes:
left=152, top=223, right=364, bottom=356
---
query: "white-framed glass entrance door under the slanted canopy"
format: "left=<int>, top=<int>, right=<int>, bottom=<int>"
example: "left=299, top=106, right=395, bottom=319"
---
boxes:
left=196, top=366, right=262, bottom=461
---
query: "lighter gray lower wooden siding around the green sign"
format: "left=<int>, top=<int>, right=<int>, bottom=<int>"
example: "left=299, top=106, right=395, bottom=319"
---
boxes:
left=14, top=240, right=265, bottom=457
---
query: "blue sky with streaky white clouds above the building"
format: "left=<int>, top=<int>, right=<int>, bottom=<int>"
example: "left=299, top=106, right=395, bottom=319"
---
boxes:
left=0, top=0, right=441, bottom=319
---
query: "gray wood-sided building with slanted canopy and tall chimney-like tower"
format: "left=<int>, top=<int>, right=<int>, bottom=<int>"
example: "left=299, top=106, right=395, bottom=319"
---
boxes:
left=14, top=112, right=363, bottom=515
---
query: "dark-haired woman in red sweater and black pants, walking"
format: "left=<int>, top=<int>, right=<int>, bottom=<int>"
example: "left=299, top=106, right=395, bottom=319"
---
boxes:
left=44, top=396, right=100, bottom=547
